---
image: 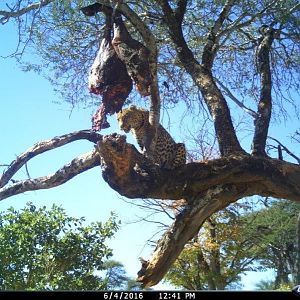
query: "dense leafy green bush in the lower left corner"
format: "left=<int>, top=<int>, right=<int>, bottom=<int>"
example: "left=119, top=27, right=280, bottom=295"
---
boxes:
left=0, top=203, right=127, bottom=290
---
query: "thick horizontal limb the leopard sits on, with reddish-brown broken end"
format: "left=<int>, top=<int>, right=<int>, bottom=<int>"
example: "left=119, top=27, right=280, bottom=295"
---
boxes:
left=98, top=135, right=300, bottom=202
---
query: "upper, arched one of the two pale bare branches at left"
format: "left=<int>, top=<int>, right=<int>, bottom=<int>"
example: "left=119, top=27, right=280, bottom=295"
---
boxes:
left=0, top=130, right=102, bottom=188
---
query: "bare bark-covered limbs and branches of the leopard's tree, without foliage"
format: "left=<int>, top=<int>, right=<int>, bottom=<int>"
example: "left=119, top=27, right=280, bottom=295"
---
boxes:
left=0, top=0, right=300, bottom=286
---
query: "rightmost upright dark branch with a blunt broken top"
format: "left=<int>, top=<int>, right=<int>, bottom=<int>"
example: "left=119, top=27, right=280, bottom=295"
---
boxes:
left=252, top=27, right=275, bottom=156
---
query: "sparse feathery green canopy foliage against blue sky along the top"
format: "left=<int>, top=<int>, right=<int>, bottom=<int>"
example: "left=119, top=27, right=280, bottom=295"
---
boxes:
left=11, top=0, right=300, bottom=114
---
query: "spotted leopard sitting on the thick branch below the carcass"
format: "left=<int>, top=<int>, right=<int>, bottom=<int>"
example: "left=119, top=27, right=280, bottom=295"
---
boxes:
left=117, top=105, right=186, bottom=170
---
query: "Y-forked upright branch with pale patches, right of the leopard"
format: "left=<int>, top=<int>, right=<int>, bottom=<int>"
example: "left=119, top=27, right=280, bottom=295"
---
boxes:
left=156, top=0, right=243, bottom=155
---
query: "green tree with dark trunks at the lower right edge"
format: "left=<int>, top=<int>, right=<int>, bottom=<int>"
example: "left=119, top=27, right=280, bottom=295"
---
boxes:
left=245, top=200, right=300, bottom=289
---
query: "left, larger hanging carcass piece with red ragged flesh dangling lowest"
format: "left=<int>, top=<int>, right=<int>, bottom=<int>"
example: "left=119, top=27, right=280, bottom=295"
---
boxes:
left=81, top=3, right=132, bottom=131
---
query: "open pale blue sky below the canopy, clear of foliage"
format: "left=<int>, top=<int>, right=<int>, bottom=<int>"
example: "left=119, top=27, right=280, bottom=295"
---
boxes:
left=0, top=11, right=299, bottom=289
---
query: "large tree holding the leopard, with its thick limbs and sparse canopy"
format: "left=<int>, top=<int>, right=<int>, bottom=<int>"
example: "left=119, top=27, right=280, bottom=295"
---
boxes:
left=0, top=0, right=300, bottom=286
